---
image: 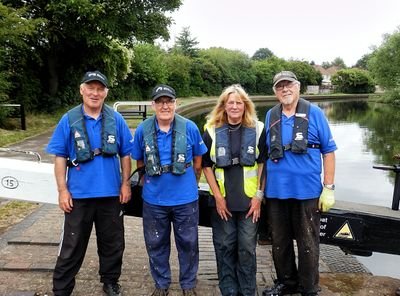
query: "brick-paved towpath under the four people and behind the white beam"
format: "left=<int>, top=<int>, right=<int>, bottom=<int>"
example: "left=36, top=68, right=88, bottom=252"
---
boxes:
left=0, top=133, right=400, bottom=296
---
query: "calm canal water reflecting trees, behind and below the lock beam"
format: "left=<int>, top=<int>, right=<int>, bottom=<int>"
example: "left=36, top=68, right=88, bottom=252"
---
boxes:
left=194, top=100, right=400, bottom=278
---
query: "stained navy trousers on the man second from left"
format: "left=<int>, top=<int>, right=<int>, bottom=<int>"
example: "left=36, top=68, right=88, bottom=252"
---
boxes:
left=143, top=200, right=199, bottom=289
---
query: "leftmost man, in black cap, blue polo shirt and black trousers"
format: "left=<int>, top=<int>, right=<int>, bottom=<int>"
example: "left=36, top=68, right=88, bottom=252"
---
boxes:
left=47, top=71, right=133, bottom=296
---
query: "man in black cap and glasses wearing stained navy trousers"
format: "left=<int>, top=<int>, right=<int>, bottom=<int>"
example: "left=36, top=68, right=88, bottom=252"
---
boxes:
left=132, top=84, right=207, bottom=296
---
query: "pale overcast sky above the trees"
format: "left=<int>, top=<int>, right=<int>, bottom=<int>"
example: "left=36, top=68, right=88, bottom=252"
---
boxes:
left=166, top=0, right=400, bottom=66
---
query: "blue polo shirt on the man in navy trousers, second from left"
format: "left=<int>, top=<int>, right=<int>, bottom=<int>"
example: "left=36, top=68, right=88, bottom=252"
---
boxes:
left=132, top=120, right=207, bottom=206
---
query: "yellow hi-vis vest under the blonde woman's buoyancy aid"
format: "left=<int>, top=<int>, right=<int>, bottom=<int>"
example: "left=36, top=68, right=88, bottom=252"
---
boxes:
left=205, top=121, right=264, bottom=198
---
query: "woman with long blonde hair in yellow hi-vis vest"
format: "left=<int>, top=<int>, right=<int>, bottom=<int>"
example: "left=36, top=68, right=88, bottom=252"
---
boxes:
left=202, top=85, right=266, bottom=296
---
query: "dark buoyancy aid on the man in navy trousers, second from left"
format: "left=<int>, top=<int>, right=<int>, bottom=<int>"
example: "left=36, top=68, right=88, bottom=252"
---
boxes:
left=143, top=114, right=190, bottom=176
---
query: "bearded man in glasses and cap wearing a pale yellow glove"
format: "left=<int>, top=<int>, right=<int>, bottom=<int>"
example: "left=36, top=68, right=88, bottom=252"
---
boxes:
left=263, top=71, right=337, bottom=296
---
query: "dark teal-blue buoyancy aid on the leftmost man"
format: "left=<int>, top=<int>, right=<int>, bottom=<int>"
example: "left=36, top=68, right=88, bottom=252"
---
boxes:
left=68, top=104, right=118, bottom=166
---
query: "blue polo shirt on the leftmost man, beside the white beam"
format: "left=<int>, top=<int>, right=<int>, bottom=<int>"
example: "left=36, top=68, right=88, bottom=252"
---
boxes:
left=46, top=106, right=133, bottom=198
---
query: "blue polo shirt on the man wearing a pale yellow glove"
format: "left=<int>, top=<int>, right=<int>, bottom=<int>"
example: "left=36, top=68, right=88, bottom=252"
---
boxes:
left=265, top=100, right=337, bottom=199
